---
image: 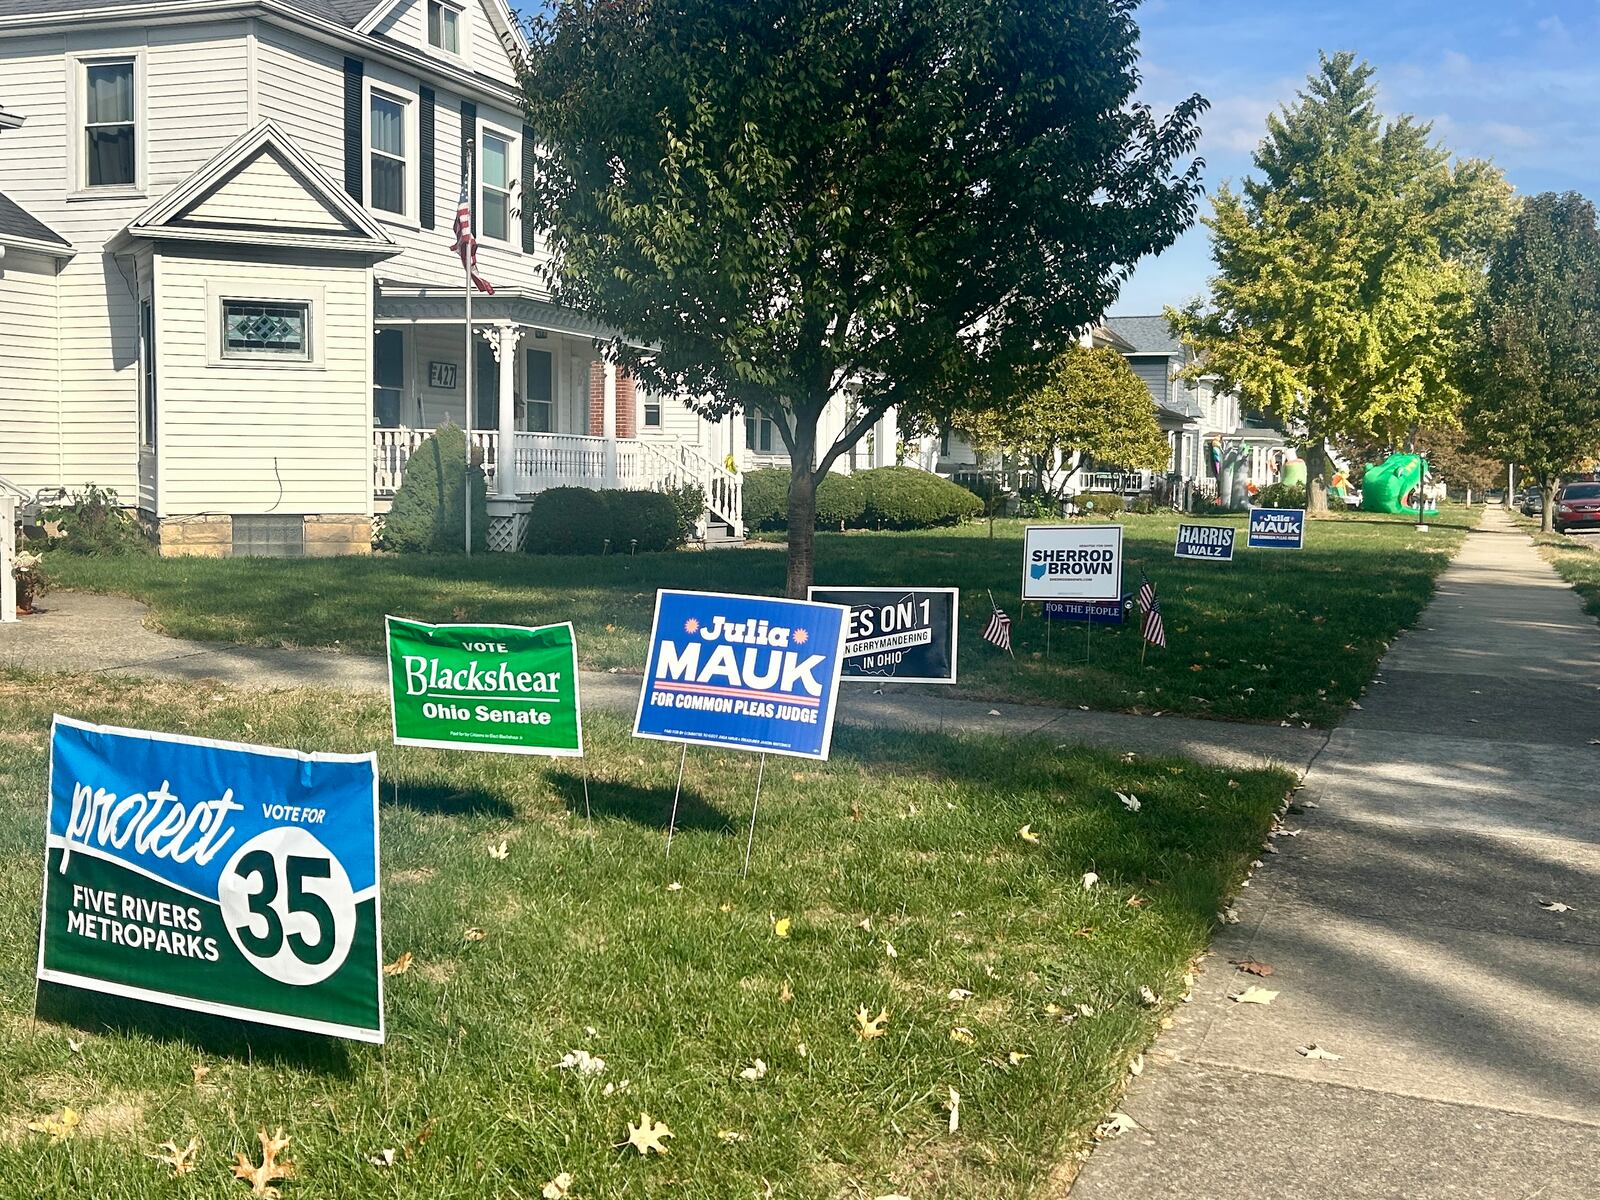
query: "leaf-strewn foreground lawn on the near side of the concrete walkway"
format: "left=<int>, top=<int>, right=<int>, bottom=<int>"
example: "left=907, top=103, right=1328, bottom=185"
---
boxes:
left=0, top=672, right=1293, bottom=1200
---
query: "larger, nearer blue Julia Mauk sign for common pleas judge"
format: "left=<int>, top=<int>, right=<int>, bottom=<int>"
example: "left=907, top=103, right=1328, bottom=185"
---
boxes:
left=634, top=590, right=850, bottom=758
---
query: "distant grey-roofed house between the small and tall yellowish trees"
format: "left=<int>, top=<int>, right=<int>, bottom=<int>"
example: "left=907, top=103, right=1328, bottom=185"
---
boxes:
left=1106, top=315, right=1285, bottom=491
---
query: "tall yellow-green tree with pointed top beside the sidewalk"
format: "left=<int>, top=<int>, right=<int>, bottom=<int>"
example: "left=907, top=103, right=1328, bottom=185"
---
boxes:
left=1168, top=53, right=1510, bottom=510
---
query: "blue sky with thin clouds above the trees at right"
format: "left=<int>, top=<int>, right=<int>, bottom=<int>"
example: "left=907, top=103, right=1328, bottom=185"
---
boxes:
left=1115, top=0, right=1600, bottom=314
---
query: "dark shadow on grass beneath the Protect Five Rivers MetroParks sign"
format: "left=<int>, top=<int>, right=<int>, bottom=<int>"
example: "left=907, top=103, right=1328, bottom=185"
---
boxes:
left=34, top=982, right=355, bottom=1078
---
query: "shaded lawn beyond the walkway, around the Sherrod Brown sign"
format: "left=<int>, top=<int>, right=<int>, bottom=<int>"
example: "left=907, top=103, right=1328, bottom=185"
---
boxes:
left=40, top=514, right=1470, bottom=726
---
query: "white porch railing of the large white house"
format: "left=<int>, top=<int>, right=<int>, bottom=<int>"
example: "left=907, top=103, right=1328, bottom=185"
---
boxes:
left=373, top=429, right=744, bottom=538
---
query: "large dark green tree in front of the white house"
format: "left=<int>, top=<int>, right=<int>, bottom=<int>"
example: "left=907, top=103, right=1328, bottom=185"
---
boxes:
left=523, top=0, right=1205, bottom=595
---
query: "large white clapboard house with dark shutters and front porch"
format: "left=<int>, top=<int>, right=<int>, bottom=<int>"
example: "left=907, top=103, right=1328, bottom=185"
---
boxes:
left=0, top=0, right=896, bottom=555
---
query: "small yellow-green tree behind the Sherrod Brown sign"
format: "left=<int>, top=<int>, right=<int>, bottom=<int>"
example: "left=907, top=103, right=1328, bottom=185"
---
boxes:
left=949, top=346, right=1171, bottom=496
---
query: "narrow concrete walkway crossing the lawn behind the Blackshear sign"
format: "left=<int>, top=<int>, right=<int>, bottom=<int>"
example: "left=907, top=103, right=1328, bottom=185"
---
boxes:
left=0, top=592, right=1328, bottom=773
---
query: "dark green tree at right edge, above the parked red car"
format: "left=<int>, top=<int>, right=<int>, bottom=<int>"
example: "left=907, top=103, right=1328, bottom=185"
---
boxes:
left=1462, top=192, right=1600, bottom=530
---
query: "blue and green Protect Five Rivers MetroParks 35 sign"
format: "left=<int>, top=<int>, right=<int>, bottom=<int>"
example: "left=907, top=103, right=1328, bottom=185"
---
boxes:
left=38, top=717, right=384, bottom=1043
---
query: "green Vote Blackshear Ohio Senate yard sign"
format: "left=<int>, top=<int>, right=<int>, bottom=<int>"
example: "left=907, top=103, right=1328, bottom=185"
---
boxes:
left=387, top=616, right=584, bottom=757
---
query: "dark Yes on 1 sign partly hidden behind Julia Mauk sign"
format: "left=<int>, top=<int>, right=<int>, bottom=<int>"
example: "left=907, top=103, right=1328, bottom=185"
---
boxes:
left=808, top=587, right=960, bottom=683
